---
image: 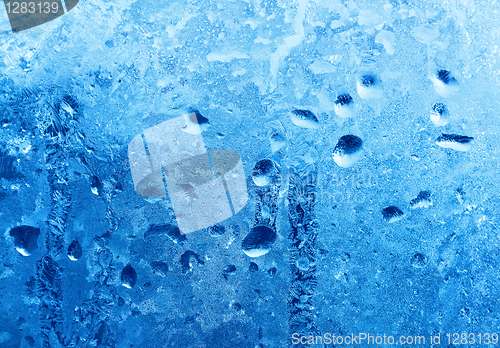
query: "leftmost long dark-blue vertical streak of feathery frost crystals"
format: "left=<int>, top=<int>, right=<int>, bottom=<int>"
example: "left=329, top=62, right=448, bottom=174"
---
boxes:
left=36, top=96, right=78, bottom=348
